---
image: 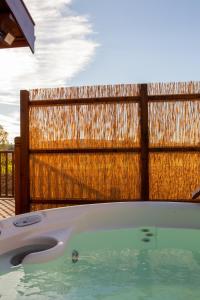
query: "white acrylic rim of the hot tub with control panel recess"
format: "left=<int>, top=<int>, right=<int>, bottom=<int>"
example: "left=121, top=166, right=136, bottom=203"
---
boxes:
left=0, top=202, right=200, bottom=265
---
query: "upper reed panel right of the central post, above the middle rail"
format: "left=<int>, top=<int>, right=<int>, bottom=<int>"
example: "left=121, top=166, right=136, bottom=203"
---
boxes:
left=148, top=100, right=200, bottom=147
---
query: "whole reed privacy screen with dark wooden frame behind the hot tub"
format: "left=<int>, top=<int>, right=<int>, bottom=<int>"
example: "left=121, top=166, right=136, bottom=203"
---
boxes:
left=15, top=82, right=200, bottom=213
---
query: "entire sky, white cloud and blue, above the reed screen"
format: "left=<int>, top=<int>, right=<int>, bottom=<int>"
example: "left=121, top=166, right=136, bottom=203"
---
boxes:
left=0, top=0, right=200, bottom=141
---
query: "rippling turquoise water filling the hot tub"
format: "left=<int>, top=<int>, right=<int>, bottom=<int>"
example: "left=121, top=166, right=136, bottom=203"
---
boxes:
left=0, top=228, right=200, bottom=300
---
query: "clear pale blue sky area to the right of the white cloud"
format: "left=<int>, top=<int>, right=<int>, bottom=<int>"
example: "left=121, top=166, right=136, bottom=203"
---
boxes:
left=71, top=0, right=200, bottom=85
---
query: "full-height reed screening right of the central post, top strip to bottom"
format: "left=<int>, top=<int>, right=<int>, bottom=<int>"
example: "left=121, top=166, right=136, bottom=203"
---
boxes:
left=148, top=82, right=200, bottom=201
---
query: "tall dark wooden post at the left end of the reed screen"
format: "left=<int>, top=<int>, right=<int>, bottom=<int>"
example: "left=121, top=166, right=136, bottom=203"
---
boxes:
left=20, top=91, right=30, bottom=213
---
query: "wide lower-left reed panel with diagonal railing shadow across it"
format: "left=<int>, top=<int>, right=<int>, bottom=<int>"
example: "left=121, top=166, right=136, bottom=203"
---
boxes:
left=30, top=153, right=140, bottom=203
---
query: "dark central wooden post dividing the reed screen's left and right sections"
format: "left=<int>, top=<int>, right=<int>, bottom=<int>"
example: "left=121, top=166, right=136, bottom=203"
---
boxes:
left=140, top=84, right=149, bottom=201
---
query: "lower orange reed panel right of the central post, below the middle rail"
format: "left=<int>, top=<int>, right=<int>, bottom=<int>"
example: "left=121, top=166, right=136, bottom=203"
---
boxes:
left=149, top=152, right=200, bottom=201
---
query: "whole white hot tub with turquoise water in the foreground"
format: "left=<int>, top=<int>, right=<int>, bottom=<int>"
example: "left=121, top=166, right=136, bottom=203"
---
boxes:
left=0, top=202, right=200, bottom=300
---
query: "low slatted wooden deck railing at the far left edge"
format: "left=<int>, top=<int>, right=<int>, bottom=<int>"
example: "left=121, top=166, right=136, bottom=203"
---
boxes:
left=0, top=151, right=14, bottom=198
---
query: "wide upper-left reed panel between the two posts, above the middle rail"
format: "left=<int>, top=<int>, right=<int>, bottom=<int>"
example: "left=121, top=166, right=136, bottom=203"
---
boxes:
left=29, top=102, right=140, bottom=149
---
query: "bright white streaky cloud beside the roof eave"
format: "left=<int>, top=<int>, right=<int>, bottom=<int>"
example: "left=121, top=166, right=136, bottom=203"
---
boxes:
left=0, top=0, right=98, bottom=142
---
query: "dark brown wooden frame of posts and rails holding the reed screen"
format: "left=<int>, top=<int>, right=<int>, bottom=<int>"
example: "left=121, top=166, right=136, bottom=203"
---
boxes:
left=16, top=84, right=200, bottom=213
